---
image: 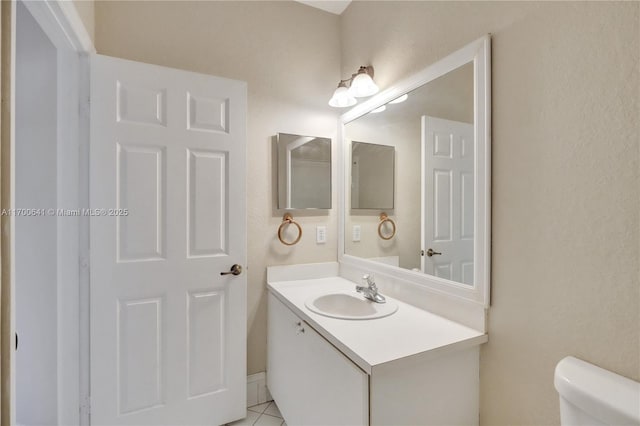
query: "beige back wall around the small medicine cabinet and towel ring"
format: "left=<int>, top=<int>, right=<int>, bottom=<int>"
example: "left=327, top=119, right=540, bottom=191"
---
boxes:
left=95, top=1, right=340, bottom=374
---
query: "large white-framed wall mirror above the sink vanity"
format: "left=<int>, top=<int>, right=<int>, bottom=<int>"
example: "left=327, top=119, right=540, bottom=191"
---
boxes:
left=340, top=36, right=490, bottom=306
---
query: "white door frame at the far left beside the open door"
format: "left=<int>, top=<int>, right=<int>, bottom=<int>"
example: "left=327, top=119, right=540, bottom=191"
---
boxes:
left=9, top=0, right=95, bottom=425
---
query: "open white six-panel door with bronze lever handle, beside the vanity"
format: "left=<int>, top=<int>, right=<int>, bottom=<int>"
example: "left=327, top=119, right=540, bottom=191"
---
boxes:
left=90, top=55, right=246, bottom=425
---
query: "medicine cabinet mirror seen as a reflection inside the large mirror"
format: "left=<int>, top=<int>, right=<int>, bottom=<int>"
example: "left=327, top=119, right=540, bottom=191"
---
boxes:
left=351, top=141, right=395, bottom=210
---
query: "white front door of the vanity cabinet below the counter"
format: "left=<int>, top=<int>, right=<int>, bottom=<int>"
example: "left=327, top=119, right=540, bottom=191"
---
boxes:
left=267, top=294, right=369, bottom=426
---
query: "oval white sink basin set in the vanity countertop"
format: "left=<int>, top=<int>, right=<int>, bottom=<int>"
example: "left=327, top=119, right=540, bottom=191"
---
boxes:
left=304, top=291, right=398, bottom=320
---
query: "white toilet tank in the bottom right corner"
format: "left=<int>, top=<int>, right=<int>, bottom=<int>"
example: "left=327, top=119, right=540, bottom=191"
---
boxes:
left=554, top=356, right=640, bottom=426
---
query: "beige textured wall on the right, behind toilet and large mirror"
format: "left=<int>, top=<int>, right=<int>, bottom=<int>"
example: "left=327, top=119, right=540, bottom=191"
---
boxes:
left=341, top=2, right=640, bottom=425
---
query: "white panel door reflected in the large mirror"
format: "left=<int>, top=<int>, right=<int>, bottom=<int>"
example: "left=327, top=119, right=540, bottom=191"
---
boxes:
left=422, top=116, right=474, bottom=285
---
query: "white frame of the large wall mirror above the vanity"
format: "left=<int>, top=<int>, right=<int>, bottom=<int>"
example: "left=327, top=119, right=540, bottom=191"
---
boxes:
left=337, top=34, right=491, bottom=308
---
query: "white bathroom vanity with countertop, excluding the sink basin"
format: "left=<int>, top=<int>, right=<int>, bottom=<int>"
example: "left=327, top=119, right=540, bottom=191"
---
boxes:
left=267, top=277, right=486, bottom=426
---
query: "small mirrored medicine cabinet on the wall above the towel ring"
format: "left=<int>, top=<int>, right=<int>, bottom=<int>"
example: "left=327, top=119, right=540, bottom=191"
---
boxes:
left=276, top=133, right=331, bottom=210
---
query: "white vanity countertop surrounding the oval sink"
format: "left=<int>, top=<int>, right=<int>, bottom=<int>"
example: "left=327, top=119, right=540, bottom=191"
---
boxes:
left=268, top=277, right=488, bottom=374
